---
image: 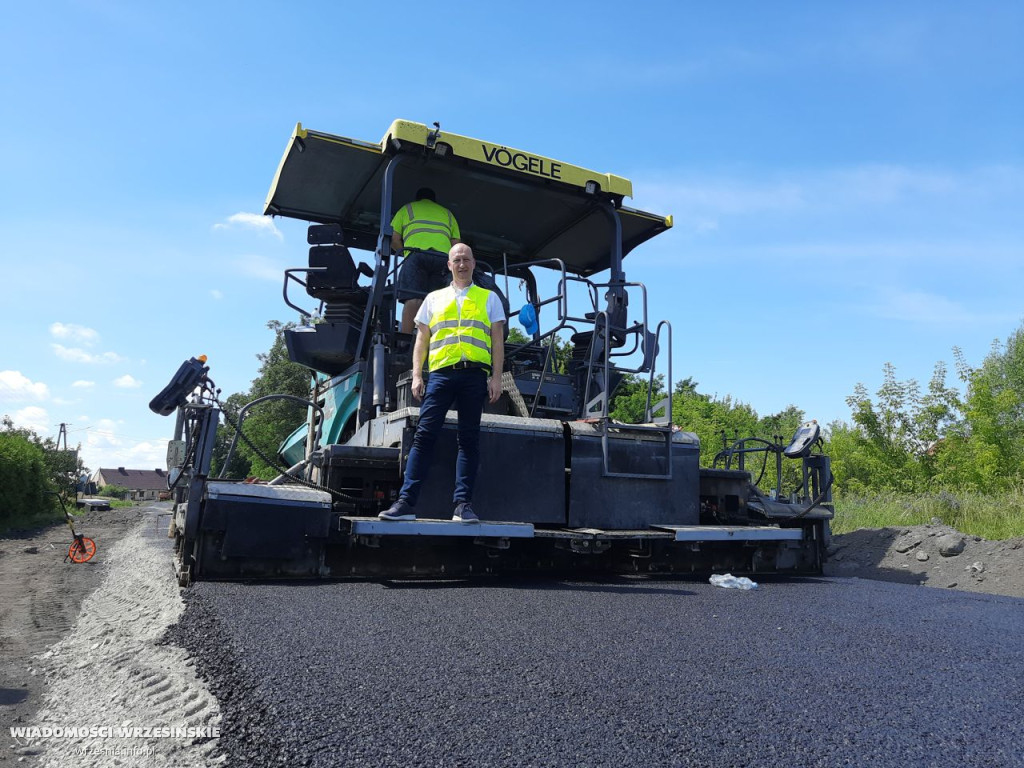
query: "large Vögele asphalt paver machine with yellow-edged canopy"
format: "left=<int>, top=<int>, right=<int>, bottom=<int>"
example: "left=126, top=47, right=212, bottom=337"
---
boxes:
left=151, top=120, right=833, bottom=584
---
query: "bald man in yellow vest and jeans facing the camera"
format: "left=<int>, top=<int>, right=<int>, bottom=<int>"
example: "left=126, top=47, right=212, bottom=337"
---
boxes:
left=379, top=243, right=506, bottom=522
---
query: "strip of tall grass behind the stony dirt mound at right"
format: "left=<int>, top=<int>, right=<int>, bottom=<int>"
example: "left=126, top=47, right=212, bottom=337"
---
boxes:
left=833, top=487, right=1024, bottom=540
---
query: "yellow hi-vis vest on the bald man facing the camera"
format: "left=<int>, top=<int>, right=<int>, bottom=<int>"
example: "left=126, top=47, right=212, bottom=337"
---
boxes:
left=427, top=285, right=490, bottom=371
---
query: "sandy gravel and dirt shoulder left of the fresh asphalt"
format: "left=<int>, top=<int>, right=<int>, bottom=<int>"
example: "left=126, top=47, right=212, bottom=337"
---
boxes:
left=0, top=504, right=220, bottom=768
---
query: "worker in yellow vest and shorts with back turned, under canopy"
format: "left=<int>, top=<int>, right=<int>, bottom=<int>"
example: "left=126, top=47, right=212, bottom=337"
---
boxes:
left=391, top=186, right=462, bottom=334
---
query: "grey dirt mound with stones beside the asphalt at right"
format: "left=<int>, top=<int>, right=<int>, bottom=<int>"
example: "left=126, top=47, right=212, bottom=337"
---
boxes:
left=825, top=521, right=1024, bottom=597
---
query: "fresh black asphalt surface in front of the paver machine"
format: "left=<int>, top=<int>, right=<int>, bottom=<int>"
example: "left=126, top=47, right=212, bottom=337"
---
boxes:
left=172, top=579, right=1024, bottom=768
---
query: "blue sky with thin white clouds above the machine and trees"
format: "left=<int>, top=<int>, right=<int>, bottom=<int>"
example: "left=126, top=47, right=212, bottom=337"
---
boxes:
left=0, top=0, right=1024, bottom=468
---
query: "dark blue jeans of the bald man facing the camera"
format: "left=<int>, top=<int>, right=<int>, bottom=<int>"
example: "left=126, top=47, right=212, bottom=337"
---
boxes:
left=398, top=368, right=487, bottom=507
